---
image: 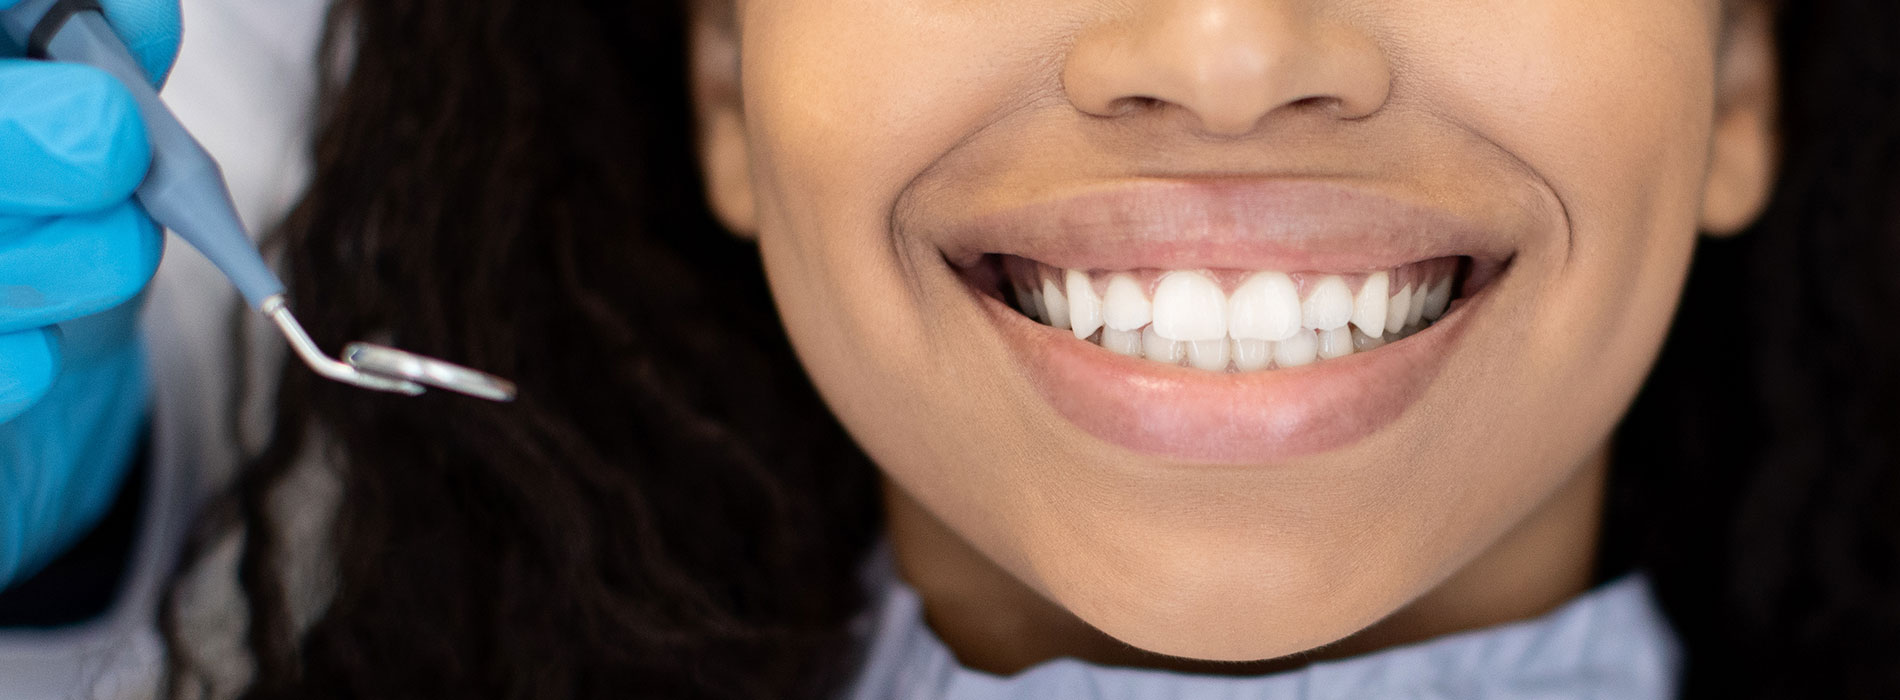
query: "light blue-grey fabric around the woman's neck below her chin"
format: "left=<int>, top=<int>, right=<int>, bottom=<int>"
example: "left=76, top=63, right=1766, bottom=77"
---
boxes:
left=846, top=552, right=1682, bottom=700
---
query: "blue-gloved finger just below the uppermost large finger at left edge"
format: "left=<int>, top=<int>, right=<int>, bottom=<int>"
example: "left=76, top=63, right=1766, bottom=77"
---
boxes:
left=0, top=202, right=165, bottom=333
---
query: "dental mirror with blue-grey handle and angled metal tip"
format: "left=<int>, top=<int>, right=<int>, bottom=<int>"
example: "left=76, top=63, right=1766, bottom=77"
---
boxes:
left=0, top=0, right=515, bottom=401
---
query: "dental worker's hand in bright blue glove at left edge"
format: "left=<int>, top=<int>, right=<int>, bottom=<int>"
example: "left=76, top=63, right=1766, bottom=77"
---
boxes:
left=0, top=0, right=181, bottom=588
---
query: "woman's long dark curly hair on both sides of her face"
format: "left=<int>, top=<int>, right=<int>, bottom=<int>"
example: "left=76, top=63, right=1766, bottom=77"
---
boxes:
left=165, top=0, right=1900, bottom=700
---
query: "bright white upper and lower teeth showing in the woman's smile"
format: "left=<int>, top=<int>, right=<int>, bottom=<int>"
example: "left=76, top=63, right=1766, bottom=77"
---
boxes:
left=1009, top=259, right=1454, bottom=371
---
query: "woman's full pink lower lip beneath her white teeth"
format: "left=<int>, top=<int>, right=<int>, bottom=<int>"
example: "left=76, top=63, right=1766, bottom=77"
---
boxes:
left=977, top=289, right=1484, bottom=464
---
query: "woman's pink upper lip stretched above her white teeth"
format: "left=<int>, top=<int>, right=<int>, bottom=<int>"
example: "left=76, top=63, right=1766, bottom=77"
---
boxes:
left=918, top=177, right=1516, bottom=272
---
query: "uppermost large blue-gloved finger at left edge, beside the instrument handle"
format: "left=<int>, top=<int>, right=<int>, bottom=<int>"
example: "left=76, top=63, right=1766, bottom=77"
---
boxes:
left=0, top=59, right=152, bottom=215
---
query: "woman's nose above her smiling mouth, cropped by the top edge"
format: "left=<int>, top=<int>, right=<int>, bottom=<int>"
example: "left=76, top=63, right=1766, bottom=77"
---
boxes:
left=1062, top=0, right=1393, bottom=137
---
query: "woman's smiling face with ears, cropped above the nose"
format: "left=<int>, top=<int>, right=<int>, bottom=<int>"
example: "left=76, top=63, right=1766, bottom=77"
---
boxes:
left=695, top=0, right=1773, bottom=660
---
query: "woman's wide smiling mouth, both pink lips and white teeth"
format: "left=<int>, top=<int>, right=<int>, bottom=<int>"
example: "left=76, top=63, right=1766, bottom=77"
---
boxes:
left=927, top=179, right=1528, bottom=466
